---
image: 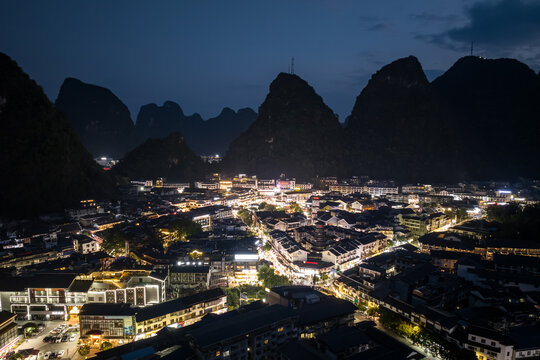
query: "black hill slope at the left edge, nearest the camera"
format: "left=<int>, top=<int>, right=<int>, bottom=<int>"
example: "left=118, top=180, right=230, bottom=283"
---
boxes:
left=0, top=53, right=115, bottom=218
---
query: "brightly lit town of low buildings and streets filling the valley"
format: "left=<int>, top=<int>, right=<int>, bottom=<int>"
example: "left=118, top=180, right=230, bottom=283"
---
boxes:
left=0, top=176, right=540, bottom=360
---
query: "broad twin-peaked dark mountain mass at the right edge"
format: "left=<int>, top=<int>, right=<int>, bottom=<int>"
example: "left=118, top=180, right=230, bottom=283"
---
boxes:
left=346, top=57, right=540, bottom=182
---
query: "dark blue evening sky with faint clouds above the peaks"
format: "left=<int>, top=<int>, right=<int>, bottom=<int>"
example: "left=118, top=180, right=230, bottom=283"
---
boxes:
left=0, top=0, right=540, bottom=120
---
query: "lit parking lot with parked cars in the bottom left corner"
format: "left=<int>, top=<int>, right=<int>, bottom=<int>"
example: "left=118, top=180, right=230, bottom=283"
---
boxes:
left=16, top=321, right=80, bottom=360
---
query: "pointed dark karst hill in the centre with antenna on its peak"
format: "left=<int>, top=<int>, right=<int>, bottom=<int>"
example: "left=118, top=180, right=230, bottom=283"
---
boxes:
left=223, top=73, right=343, bottom=179
